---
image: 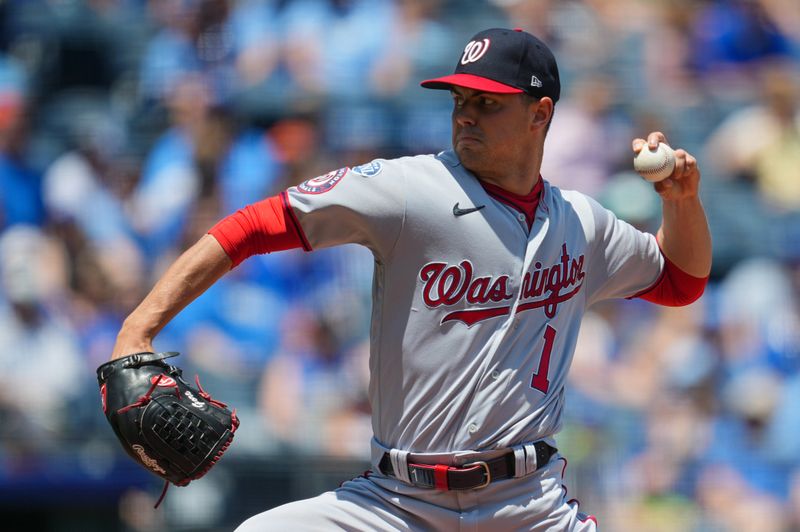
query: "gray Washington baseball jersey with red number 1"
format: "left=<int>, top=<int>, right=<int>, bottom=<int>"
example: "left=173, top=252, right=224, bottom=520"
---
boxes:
left=288, top=151, right=663, bottom=453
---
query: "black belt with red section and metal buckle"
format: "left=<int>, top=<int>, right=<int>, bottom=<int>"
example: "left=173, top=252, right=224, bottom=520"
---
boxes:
left=378, top=441, right=558, bottom=491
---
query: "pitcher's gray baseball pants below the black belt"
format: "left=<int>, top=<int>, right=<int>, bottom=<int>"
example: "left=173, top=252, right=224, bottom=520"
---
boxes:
left=236, top=458, right=597, bottom=532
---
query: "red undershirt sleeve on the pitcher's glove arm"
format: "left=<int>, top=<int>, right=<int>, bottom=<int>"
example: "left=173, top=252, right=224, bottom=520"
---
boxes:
left=208, top=192, right=311, bottom=268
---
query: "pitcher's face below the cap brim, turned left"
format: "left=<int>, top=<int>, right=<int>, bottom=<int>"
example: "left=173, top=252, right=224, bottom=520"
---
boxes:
left=450, top=86, right=536, bottom=183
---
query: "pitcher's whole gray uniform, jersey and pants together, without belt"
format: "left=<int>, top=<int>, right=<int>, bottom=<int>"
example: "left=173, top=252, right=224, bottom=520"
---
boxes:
left=237, top=151, right=663, bottom=532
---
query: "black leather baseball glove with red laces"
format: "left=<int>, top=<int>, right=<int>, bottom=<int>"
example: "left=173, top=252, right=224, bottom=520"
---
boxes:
left=97, top=352, right=239, bottom=506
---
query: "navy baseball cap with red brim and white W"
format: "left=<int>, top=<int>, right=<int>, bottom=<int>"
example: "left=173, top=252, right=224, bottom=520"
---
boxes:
left=420, top=28, right=561, bottom=102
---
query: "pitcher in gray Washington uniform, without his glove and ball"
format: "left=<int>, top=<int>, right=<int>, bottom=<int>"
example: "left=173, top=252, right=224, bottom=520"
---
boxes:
left=112, top=29, right=711, bottom=532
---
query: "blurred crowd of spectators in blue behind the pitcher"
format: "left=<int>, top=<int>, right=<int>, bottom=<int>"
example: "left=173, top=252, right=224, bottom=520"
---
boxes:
left=0, top=0, right=800, bottom=532
